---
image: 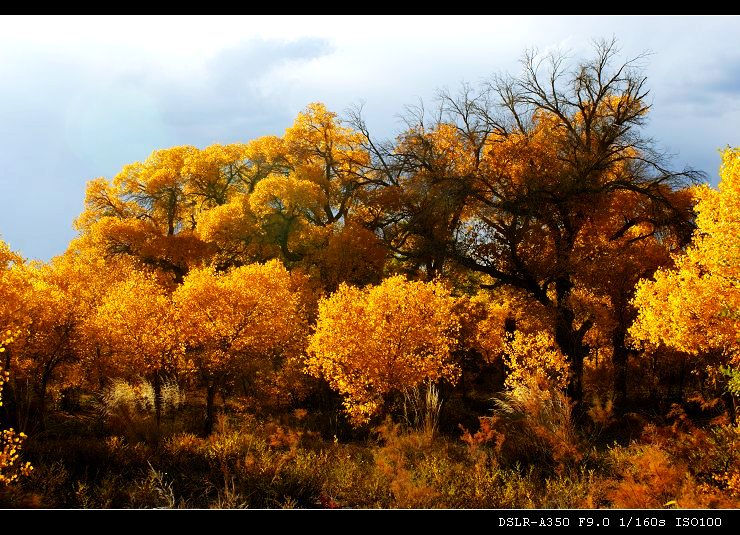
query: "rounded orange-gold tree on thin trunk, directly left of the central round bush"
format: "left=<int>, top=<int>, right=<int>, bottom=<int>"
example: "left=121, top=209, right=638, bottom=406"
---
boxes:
left=173, top=260, right=305, bottom=434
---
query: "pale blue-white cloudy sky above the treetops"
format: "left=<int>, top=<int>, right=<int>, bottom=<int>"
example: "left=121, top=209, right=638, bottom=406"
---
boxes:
left=0, top=16, right=740, bottom=259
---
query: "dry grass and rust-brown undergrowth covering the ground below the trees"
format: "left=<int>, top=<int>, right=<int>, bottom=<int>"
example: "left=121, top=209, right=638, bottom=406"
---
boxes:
left=0, top=384, right=740, bottom=508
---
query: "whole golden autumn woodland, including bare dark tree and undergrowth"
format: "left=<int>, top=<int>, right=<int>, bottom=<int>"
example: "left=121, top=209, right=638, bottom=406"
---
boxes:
left=0, top=41, right=740, bottom=508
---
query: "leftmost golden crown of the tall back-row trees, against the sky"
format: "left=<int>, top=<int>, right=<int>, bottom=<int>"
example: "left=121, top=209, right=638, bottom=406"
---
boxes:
left=76, top=146, right=224, bottom=282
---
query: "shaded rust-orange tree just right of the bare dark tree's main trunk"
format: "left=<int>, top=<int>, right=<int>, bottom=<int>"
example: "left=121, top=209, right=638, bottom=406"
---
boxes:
left=572, top=188, right=694, bottom=412
